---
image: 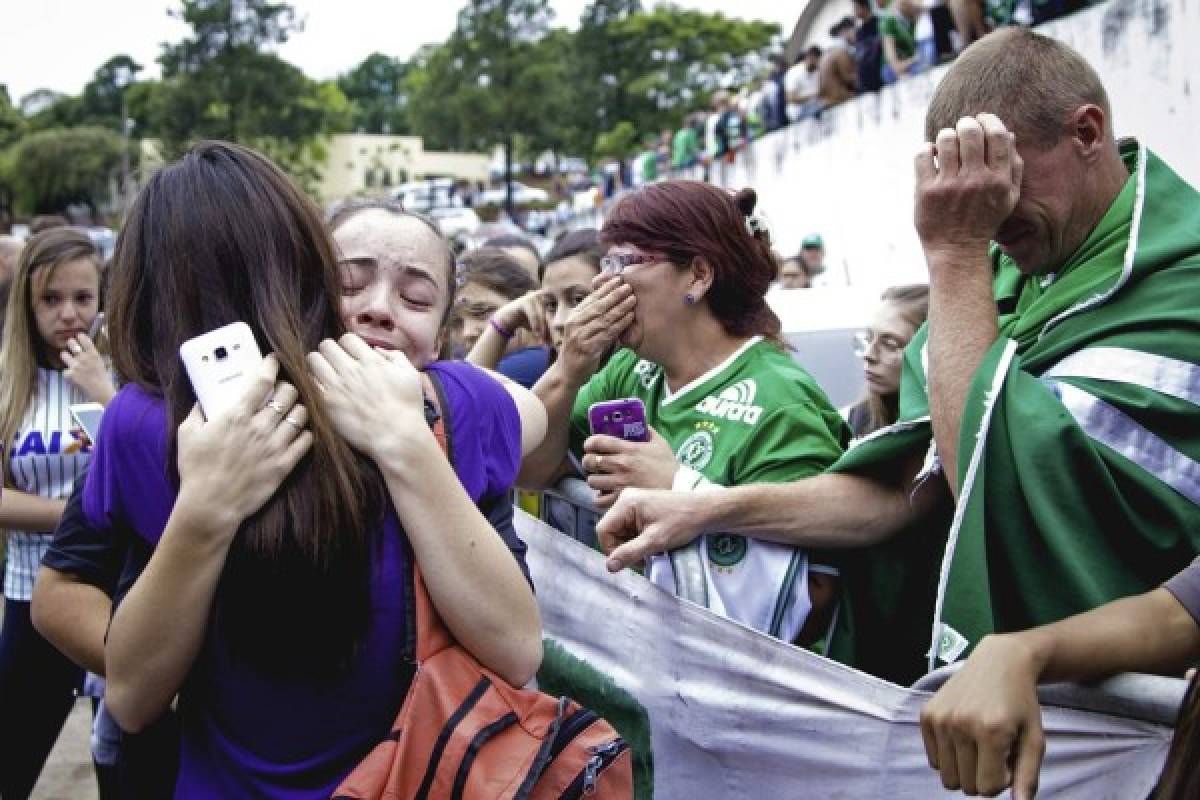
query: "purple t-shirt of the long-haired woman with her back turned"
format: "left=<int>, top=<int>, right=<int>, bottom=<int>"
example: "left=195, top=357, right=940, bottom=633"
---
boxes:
left=84, top=362, right=521, bottom=800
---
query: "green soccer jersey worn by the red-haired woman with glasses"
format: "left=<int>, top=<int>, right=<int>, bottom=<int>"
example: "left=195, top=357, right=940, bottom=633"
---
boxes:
left=571, top=337, right=850, bottom=486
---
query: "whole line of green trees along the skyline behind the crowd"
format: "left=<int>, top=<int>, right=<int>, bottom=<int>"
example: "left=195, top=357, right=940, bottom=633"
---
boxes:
left=0, top=0, right=779, bottom=212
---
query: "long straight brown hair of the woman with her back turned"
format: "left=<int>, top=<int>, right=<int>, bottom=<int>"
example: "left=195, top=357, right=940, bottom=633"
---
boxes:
left=109, top=142, right=384, bottom=670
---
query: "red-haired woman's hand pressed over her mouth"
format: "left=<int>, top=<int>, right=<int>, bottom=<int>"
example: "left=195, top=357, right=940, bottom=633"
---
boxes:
left=558, top=273, right=637, bottom=385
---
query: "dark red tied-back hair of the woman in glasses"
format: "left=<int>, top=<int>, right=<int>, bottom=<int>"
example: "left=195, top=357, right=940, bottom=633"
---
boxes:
left=600, top=181, right=782, bottom=347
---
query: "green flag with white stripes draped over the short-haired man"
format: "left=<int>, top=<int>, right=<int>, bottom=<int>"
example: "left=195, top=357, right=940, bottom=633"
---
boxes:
left=833, top=142, right=1200, bottom=681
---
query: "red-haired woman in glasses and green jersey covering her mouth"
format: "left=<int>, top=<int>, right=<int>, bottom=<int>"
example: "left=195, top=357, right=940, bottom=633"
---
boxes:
left=522, top=181, right=850, bottom=643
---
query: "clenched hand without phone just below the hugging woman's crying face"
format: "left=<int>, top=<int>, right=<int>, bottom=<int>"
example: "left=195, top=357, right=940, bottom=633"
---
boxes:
left=308, top=333, right=428, bottom=464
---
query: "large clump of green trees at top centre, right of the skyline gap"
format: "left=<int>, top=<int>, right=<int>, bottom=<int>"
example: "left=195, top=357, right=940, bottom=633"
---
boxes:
left=407, top=0, right=779, bottom=164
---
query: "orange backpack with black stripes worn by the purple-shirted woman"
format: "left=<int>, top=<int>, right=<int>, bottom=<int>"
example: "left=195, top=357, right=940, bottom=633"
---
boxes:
left=334, top=373, right=634, bottom=800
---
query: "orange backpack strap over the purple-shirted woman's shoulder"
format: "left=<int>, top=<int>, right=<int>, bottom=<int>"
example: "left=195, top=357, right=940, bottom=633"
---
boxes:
left=404, top=372, right=454, bottom=664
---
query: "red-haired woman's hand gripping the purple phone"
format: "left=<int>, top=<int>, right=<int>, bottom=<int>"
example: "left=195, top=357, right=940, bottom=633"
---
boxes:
left=583, top=426, right=679, bottom=509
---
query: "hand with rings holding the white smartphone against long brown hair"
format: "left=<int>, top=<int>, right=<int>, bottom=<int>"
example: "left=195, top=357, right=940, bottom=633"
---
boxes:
left=178, top=354, right=312, bottom=540
